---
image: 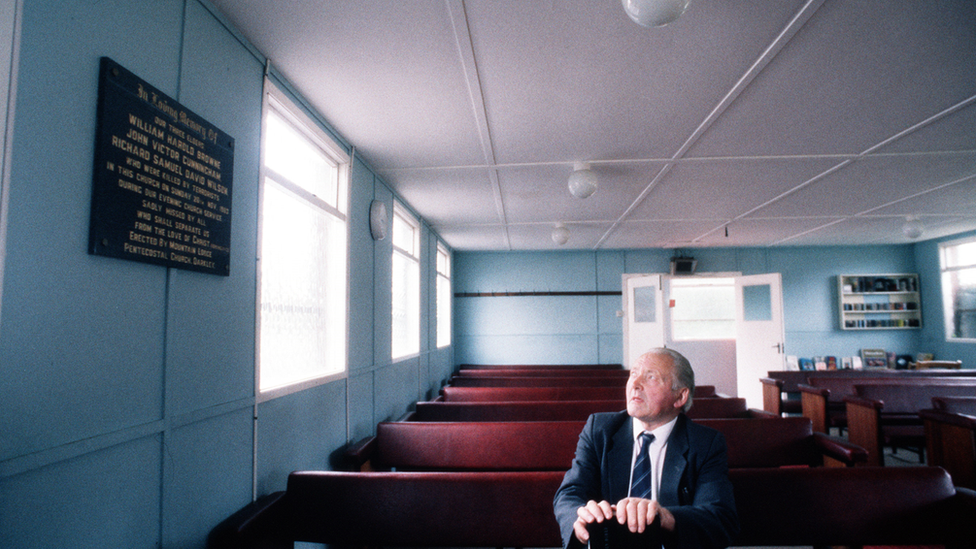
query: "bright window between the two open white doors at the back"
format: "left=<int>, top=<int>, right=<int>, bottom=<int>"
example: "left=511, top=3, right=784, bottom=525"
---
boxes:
left=670, top=277, right=735, bottom=341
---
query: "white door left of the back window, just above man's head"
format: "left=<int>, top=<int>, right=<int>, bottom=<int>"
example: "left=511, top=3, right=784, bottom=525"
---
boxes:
left=623, top=274, right=664, bottom=368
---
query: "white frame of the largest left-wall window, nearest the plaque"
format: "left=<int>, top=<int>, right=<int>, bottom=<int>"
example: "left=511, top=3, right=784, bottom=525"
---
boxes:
left=254, top=78, right=352, bottom=403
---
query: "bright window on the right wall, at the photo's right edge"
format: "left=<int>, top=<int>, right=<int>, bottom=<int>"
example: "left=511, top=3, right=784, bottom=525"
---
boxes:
left=939, top=238, right=976, bottom=341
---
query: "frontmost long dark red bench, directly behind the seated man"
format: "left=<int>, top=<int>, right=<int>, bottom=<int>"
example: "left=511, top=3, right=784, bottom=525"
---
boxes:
left=208, top=467, right=976, bottom=549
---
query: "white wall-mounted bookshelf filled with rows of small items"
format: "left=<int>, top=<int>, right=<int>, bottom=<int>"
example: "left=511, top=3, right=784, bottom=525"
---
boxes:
left=837, top=273, right=922, bottom=330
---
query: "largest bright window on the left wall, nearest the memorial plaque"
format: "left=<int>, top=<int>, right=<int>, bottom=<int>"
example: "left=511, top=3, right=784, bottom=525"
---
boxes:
left=257, top=82, right=349, bottom=399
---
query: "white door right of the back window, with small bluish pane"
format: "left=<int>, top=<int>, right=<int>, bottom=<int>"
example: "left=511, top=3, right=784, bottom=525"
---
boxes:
left=735, top=273, right=786, bottom=409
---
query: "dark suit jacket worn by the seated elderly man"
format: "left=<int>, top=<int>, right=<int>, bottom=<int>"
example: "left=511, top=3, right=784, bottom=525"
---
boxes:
left=553, top=412, right=739, bottom=549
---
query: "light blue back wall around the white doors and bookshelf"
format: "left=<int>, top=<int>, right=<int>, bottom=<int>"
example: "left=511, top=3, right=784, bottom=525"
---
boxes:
left=454, top=244, right=952, bottom=364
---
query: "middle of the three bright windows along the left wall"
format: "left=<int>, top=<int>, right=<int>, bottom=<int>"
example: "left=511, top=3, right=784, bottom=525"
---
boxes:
left=392, top=202, right=420, bottom=359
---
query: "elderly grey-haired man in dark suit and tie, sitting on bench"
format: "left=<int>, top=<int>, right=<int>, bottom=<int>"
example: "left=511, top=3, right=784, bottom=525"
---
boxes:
left=553, top=349, right=739, bottom=549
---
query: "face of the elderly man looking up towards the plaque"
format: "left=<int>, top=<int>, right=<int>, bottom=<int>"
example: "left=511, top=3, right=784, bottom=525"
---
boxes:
left=627, top=354, right=688, bottom=427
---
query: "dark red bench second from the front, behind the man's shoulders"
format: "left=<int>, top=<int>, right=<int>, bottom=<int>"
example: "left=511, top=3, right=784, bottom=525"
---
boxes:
left=346, top=417, right=867, bottom=472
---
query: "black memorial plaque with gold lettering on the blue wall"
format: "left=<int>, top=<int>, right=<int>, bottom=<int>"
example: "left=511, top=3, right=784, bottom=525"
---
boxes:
left=88, top=57, right=234, bottom=276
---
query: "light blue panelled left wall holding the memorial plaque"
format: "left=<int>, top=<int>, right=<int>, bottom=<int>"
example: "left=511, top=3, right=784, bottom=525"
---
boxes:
left=0, top=0, right=454, bottom=549
